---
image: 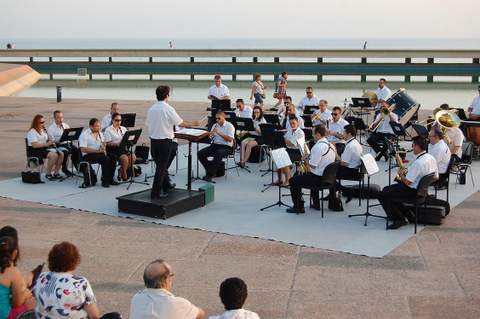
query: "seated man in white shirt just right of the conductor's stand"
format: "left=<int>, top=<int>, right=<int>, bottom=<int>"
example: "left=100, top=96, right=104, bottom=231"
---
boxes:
left=198, top=111, right=235, bottom=182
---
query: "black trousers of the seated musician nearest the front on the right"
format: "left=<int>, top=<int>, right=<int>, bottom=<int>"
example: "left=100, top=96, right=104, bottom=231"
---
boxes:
left=378, top=183, right=417, bottom=221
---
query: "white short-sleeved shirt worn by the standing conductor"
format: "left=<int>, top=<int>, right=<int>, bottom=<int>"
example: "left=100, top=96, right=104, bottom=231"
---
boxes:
left=145, top=101, right=183, bottom=140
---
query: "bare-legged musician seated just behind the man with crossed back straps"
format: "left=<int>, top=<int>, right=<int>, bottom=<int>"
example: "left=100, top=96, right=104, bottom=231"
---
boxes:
left=275, top=114, right=305, bottom=186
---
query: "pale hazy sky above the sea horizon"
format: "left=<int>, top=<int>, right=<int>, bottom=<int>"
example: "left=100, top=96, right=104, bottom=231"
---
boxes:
left=0, top=0, right=480, bottom=39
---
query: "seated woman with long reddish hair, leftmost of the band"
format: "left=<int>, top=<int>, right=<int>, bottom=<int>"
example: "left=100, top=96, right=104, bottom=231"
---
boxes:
left=26, top=114, right=63, bottom=180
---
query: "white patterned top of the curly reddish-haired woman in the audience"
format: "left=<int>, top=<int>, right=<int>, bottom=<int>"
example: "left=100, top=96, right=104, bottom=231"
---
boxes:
left=33, top=272, right=96, bottom=319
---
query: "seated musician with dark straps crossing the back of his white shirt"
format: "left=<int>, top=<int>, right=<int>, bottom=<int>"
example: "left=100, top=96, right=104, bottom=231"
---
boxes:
left=287, top=125, right=336, bottom=214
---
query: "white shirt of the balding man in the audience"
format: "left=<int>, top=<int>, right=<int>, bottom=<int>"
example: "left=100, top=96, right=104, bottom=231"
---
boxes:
left=129, top=288, right=198, bottom=319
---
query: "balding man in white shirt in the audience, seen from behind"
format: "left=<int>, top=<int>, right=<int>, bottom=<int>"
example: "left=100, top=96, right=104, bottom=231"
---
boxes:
left=129, top=259, right=205, bottom=319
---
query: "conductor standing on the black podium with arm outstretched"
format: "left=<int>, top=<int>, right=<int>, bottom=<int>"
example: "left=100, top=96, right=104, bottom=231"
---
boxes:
left=145, top=85, right=195, bottom=198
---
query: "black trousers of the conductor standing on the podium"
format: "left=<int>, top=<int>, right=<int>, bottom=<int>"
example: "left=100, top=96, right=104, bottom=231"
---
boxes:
left=150, top=138, right=174, bottom=195
